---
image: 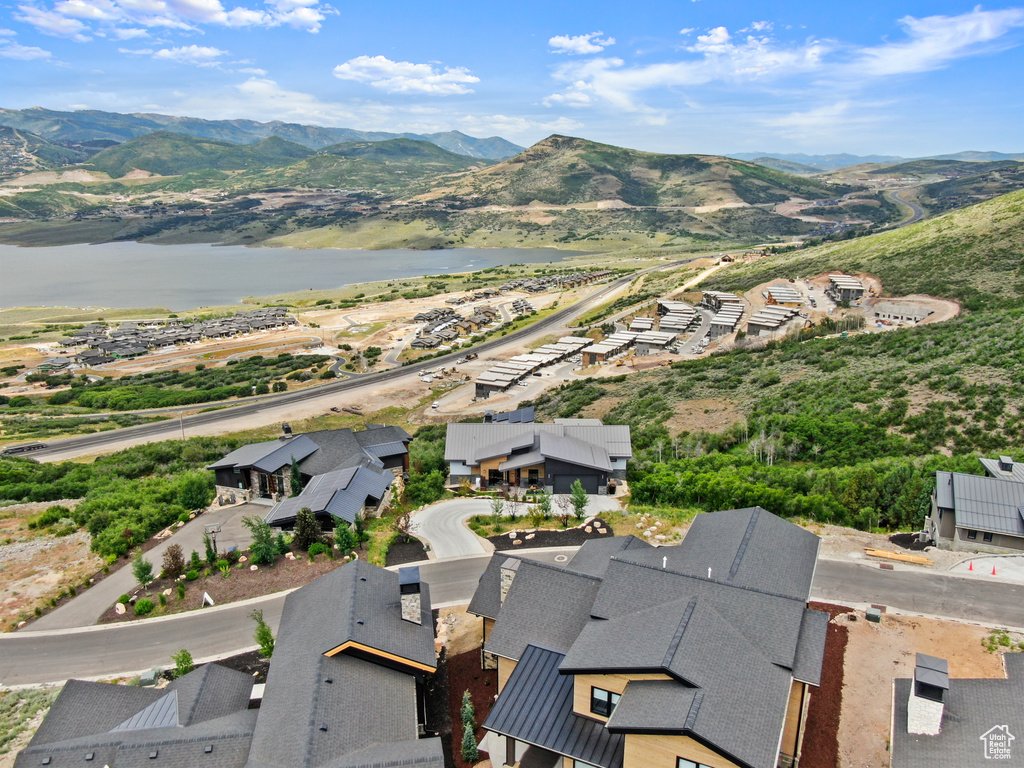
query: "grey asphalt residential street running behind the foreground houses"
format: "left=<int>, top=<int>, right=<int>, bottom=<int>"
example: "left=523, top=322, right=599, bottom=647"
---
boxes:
left=0, top=550, right=1024, bottom=685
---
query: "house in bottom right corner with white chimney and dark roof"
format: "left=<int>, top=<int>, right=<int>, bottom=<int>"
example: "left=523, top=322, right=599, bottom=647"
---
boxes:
left=890, top=653, right=1024, bottom=768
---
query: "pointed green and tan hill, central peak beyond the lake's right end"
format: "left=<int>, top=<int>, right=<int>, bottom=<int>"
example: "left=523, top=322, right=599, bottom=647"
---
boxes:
left=436, top=135, right=853, bottom=206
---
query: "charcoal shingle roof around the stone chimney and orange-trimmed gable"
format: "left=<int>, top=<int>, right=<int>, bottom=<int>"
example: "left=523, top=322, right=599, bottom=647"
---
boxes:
left=248, top=560, right=436, bottom=768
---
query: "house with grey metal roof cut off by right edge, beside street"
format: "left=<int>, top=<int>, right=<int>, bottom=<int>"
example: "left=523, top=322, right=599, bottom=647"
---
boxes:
left=925, top=457, right=1024, bottom=553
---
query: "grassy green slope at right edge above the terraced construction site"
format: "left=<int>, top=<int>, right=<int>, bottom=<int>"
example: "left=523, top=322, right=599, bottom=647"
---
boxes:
left=708, top=190, right=1024, bottom=309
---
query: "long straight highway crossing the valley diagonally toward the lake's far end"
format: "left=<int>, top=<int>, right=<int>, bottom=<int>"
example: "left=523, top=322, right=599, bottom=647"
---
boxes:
left=32, top=257, right=696, bottom=461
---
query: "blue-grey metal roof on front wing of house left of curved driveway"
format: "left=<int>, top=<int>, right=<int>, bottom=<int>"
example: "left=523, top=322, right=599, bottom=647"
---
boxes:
left=263, top=467, right=394, bottom=526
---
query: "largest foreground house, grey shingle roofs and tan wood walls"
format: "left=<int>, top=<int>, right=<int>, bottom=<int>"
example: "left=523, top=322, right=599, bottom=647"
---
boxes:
left=469, top=507, right=828, bottom=768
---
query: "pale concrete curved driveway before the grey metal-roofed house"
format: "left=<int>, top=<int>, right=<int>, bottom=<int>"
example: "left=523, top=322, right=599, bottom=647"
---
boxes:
left=412, top=496, right=622, bottom=559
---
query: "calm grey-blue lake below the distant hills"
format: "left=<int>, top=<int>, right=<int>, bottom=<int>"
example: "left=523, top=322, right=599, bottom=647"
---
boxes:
left=0, top=243, right=579, bottom=310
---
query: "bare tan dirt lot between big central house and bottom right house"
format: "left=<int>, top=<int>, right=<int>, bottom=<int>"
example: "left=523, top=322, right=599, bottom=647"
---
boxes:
left=834, top=611, right=1007, bottom=768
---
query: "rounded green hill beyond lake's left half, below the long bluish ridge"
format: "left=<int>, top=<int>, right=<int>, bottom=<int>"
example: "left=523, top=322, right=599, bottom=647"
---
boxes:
left=83, top=131, right=313, bottom=178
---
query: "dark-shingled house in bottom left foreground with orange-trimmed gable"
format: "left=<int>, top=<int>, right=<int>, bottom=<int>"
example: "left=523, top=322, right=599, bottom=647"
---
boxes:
left=15, top=560, right=444, bottom=768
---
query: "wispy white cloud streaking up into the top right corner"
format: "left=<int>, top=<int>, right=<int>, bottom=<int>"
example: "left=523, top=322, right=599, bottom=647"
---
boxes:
left=854, top=6, right=1024, bottom=77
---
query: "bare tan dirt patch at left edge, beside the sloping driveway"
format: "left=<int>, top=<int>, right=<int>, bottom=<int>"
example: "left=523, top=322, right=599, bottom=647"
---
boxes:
left=0, top=501, right=103, bottom=630
